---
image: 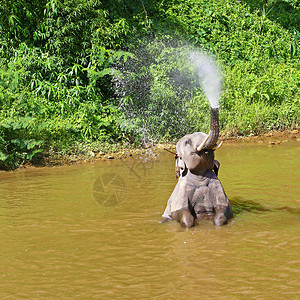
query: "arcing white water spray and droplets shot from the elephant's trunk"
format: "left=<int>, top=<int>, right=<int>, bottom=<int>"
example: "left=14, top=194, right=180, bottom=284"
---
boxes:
left=114, top=41, right=222, bottom=144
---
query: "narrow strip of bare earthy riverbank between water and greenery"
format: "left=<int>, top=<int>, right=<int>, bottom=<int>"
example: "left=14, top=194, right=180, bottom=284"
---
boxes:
left=15, top=129, right=300, bottom=169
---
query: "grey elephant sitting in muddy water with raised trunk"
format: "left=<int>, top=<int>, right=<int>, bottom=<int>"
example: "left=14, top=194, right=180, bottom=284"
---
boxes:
left=162, top=108, right=233, bottom=228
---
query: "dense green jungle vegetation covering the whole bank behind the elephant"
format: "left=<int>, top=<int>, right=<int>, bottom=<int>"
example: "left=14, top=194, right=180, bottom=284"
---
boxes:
left=0, top=0, right=300, bottom=169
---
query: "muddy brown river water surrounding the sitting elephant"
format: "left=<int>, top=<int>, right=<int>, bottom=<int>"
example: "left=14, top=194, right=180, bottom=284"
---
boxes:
left=0, top=141, right=300, bottom=299
